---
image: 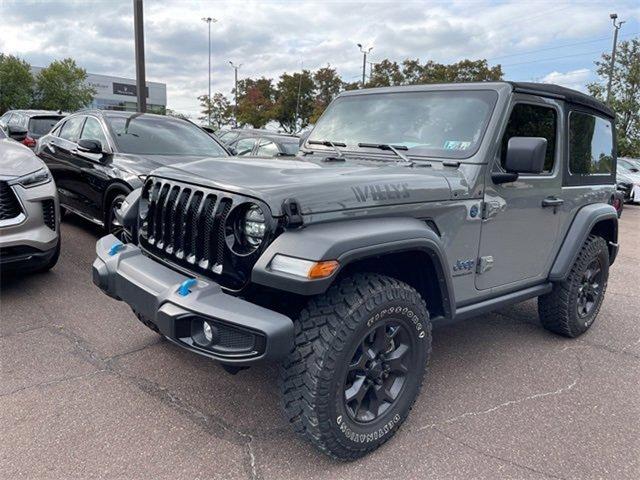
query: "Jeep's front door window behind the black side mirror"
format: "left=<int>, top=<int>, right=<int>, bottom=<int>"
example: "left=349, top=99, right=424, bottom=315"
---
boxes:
left=500, top=103, right=558, bottom=173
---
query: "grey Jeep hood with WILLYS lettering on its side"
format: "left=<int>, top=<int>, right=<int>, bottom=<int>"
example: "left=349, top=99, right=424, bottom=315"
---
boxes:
left=152, top=157, right=460, bottom=216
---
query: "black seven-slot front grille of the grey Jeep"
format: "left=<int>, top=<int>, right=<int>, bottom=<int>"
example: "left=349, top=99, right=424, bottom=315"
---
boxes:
left=140, top=178, right=233, bottom=273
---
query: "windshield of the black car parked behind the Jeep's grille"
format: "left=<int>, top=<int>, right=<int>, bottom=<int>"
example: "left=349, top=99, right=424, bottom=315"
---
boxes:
left=107, top=115, right=227, bottom=157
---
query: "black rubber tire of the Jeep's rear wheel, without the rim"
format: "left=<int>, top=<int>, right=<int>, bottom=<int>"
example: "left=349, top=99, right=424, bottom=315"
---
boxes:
left=538, top=235, right=609, bottom=338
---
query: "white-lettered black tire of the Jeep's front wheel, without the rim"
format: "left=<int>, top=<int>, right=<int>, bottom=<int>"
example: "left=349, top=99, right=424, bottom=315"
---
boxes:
left=280, top=274, right=431, bottom=460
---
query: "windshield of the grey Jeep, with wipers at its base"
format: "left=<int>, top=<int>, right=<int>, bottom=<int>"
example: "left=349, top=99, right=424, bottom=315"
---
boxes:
left=309, top=90, right=498, bottom=158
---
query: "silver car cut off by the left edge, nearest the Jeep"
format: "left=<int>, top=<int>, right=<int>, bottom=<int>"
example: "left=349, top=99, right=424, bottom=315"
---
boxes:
left=0, top=137, right=60, bottom=272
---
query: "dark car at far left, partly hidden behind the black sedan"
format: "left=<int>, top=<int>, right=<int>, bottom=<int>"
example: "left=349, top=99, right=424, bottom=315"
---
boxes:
left=0, top=110, right=65, bottom=150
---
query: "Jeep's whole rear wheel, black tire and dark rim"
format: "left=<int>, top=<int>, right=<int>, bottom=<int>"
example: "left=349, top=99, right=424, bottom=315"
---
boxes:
left=538, top=235, right=609, bottom=338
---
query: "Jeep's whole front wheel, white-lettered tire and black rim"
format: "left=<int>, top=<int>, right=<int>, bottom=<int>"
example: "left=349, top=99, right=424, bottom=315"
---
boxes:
left=280, top=274, right=431, bottom=460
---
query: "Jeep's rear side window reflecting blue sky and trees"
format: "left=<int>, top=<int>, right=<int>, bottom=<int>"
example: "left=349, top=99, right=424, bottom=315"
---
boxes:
left=569, top=111, right=614, bottom=175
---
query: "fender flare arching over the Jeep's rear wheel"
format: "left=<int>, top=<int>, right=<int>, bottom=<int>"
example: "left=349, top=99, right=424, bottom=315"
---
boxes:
left=549, top=203, right=618, bottom=282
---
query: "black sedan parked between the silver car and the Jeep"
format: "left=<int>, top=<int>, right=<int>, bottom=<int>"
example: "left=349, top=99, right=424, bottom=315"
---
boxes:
left=36, top=110, right=228, bottom=236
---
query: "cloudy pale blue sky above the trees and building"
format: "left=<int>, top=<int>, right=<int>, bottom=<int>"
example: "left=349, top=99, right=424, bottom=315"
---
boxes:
left=0, top=0, right=640, bottom=118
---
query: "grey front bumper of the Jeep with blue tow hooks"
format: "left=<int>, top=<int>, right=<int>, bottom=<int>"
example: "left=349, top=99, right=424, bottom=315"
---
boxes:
left=93, top=235, right=294, bottom=366
